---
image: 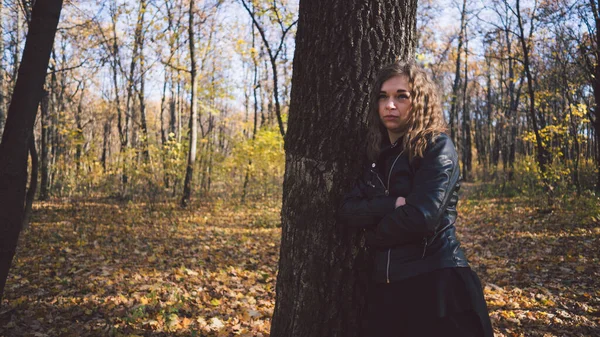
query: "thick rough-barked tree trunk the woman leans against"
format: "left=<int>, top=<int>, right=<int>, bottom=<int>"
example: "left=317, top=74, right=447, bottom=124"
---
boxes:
left=271, top=0, right=417, bottom=337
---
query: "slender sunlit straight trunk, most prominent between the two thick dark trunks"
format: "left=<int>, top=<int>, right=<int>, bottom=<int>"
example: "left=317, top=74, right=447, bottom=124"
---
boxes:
left=181, top=0, right=198, bottom=207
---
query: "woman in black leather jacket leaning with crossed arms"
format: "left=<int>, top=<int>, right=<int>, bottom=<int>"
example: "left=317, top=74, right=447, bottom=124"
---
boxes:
left=339, top=62, right=493, bottom=337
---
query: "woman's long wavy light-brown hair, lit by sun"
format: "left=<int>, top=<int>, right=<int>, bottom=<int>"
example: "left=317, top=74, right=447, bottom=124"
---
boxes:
left=367, top=61, right=448, bottom=161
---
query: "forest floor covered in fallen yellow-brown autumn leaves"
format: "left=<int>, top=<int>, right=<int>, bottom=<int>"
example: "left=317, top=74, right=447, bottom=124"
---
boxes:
left=0, top=185, right=600, bottom=337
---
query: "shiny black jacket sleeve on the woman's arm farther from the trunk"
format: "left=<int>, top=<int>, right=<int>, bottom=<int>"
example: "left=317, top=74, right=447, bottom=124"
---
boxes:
left=369, top=134, right=460, bottom=246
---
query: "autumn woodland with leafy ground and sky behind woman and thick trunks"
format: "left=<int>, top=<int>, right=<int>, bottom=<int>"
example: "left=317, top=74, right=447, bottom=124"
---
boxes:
left=0, top=0, right=600, bottom=336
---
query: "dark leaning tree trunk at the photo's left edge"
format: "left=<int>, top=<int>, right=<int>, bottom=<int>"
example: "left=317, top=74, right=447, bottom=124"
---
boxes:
left=0, top=0, right=62, bottom=303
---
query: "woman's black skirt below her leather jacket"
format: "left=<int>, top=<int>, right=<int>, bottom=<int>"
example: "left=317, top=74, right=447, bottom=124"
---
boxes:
left=367, top=267, right=493, bottom=337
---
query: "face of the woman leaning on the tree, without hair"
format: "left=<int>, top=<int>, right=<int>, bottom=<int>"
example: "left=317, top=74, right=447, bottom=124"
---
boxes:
left=379, top=75, right=412, bottom=136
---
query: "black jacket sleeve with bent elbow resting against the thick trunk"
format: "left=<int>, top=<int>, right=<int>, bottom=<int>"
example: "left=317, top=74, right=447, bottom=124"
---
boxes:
left=338, top=167, right=396, bottom=228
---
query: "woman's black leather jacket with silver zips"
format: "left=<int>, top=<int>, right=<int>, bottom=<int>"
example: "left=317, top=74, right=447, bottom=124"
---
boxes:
left=338, top=134, right=468, bottom=283
